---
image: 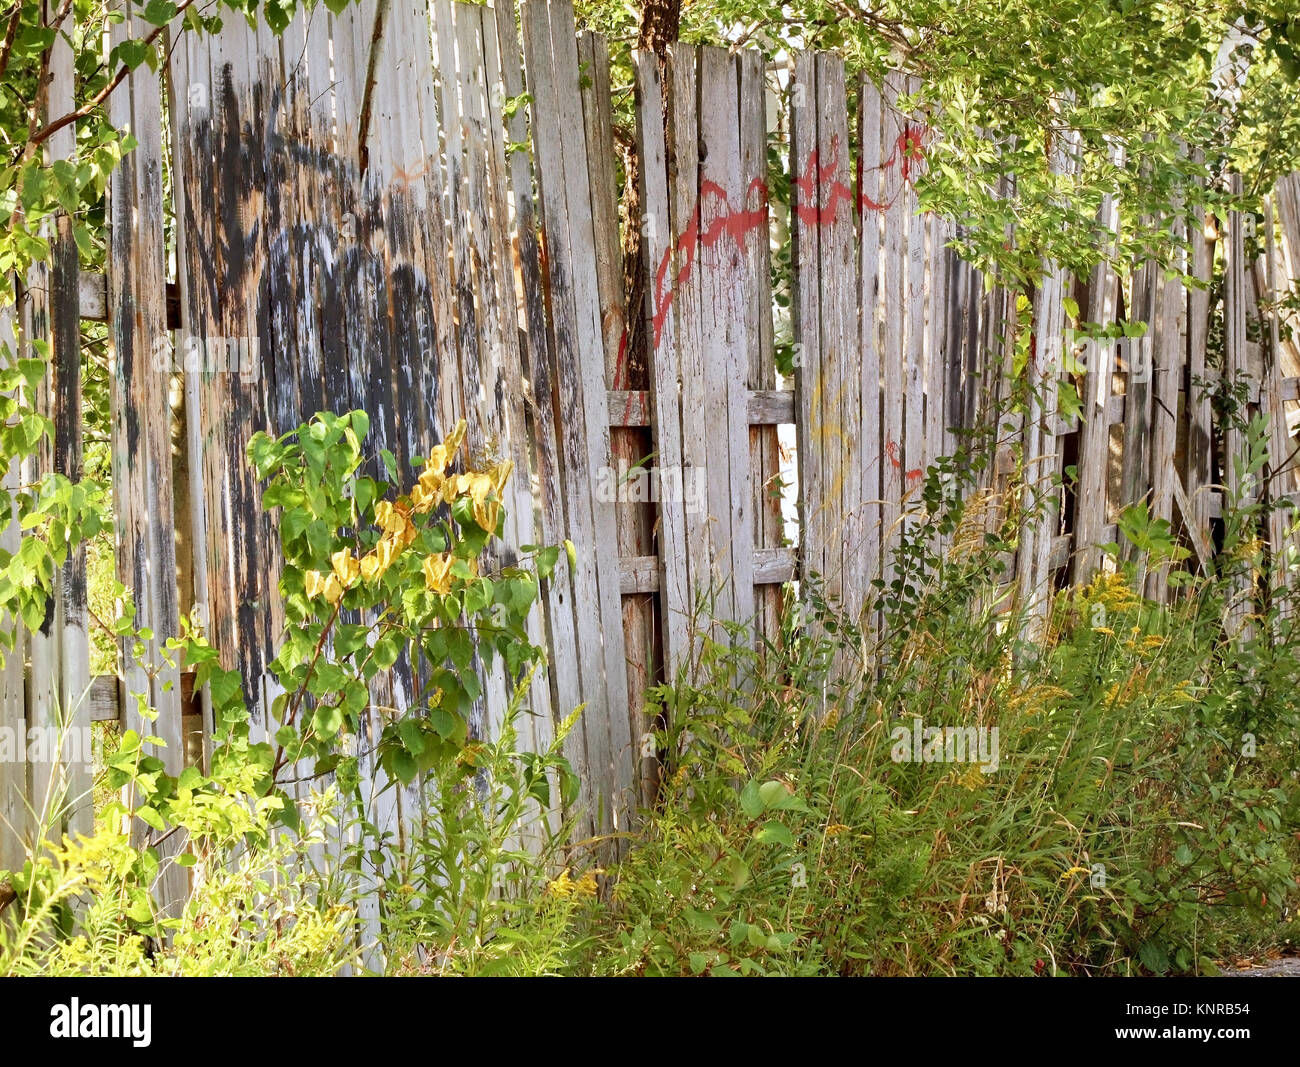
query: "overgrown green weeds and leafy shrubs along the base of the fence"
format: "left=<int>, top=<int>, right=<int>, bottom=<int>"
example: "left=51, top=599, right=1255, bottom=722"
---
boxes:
left=0, top=413, right=1300, bottom=975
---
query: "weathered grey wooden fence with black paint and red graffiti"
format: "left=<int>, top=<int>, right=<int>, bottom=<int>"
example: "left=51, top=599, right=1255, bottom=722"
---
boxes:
left=0, top=0, right=1300, bottom=876
